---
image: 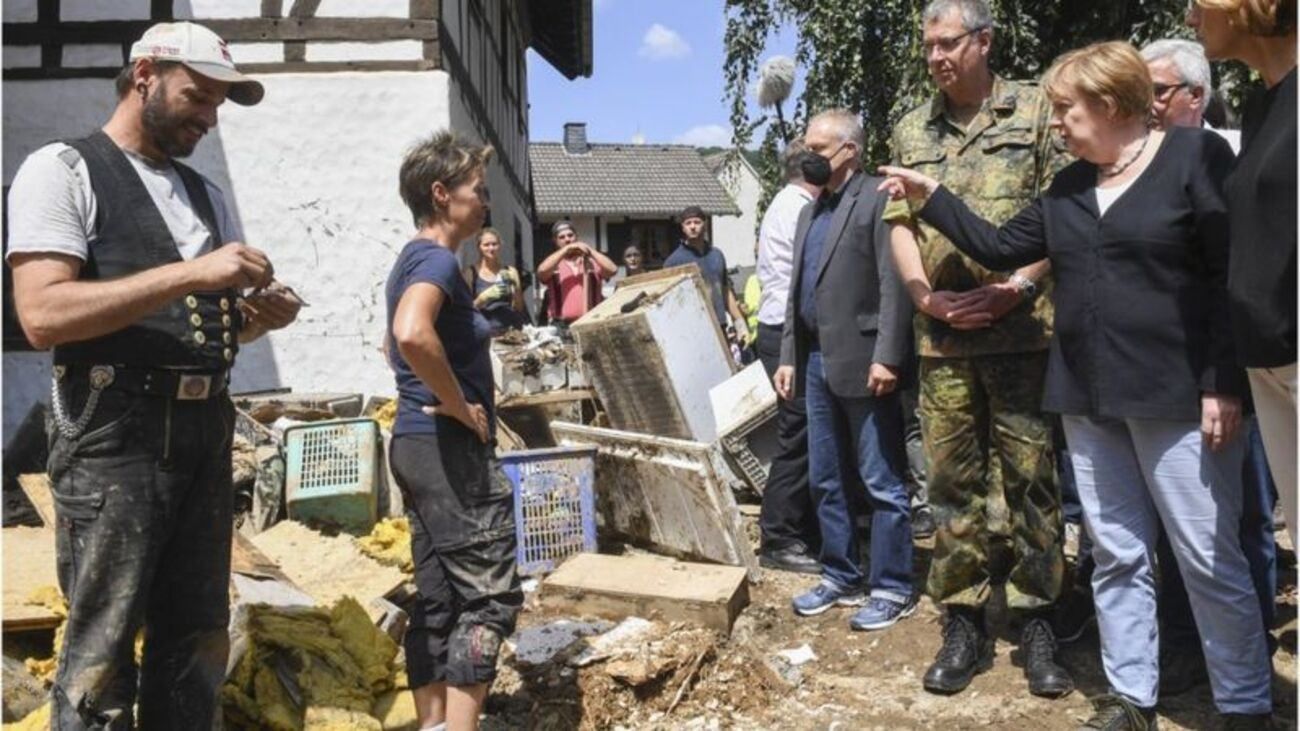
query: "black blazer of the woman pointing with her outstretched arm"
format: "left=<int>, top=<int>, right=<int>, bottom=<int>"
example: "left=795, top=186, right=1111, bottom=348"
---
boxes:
left=920, top=127, right=1247, bottom=420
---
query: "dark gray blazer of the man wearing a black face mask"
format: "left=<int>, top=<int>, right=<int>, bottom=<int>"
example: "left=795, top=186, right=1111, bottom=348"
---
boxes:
left=781, top=173, right=911, bottom=398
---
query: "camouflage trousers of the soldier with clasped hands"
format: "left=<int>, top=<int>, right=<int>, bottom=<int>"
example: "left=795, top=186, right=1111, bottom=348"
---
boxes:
left=920, top=352, right=1065, bottom=610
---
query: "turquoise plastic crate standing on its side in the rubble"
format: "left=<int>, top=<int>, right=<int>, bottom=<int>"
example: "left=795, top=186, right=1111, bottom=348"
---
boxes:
left=285, top=419, right=380, bottom=535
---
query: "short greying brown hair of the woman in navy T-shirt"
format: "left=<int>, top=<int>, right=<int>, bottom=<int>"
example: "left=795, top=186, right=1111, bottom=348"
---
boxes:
left=398, top=130, right=493, bottom=226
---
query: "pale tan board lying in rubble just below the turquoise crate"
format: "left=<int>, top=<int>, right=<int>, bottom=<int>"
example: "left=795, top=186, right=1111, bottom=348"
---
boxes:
left=250, top=520, right=407, bottom=606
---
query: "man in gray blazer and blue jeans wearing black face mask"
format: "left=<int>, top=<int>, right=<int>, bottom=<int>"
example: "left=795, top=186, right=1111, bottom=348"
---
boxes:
left=774, top=109, right=917, bottom=630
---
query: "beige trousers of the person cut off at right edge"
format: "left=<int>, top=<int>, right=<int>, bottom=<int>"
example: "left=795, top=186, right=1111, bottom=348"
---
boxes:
left=1247, top=363, right=1300, bottom=545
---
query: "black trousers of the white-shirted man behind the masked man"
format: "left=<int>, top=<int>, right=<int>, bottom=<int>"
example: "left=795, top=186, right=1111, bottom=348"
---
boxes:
left=758, top=323, right=822, bottom=555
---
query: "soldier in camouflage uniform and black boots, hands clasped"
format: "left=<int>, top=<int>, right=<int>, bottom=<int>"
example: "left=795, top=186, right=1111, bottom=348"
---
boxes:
left=885, top=0, right=1074, bottom=697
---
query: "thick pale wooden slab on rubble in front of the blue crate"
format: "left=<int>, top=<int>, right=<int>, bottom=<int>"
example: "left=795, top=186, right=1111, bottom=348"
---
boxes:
left=541, top=553, right=749, bottom=633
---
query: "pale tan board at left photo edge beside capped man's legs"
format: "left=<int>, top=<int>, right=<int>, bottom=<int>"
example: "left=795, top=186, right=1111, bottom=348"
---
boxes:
left=0, top=525, right=62, bottom=632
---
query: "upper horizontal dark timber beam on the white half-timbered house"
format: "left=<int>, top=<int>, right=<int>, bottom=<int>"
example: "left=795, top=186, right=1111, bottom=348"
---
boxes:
left=4, top=18, right=438, bottom=46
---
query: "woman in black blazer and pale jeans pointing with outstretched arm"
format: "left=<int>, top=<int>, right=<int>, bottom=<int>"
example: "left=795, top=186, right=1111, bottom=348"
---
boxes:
left=881, top=42, right=1271, bottom=728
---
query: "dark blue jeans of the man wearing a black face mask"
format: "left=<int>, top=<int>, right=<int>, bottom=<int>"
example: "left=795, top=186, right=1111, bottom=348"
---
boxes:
left=806, top=351, right=913, bottom=601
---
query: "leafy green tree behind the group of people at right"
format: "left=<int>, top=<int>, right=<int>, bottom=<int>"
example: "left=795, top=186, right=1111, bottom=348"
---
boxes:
left=724, top=0, right=1249, bottom=207
